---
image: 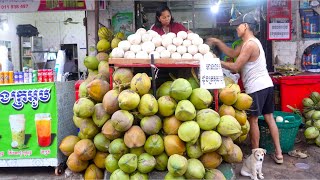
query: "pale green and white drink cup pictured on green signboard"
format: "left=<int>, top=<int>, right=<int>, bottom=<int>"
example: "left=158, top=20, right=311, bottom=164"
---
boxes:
left=9, top=114, right=26, bottom=148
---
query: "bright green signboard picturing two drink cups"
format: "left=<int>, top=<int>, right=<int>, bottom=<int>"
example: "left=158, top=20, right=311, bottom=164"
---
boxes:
left=0, top=83, right=58, bottom=159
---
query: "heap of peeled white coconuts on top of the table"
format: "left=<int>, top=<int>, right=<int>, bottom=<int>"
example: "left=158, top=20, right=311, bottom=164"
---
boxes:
left=111, top=28, right=216, bottom=60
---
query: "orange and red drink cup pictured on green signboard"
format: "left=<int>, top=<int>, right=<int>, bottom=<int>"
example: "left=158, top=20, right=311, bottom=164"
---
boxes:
left=35, top=113, right=51, bottom=147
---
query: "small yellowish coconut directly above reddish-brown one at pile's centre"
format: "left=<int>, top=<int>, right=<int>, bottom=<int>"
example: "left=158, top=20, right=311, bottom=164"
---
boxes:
left=158, top=96, right=177, bottom=116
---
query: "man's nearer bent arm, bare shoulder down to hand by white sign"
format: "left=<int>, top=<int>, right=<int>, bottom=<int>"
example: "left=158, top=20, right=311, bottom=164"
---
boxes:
left=221, top=41, right=256, bottom=73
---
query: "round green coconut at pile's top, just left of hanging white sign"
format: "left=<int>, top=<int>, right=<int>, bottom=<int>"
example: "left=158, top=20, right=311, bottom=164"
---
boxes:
left=170, top=78, right=192, bottom=101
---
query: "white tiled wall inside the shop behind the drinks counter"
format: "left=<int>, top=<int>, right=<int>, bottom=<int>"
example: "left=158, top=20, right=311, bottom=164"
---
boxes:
left=0, top=11, right=86, bottom=71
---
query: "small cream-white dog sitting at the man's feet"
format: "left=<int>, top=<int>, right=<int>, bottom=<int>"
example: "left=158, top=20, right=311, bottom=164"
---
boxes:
left=241, top=148, right=267, bottom=180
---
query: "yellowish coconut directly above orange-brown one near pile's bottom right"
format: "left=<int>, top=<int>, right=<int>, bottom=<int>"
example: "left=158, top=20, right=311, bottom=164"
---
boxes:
left=200, top=131, right=222, bottom=153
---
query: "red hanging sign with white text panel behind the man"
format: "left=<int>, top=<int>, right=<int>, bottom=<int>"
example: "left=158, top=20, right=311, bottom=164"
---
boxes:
left=267, top=0, right=291, bottom=40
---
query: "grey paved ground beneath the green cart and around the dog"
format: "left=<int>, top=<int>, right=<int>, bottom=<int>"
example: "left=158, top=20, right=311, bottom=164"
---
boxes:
left=0, top=129, right=320, bottom=180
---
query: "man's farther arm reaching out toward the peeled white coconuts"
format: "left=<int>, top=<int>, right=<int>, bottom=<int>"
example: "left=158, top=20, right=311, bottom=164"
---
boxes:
left=206, top=38, right=242, bottom=58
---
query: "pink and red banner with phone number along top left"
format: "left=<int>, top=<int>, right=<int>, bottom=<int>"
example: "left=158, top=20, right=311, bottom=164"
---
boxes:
left=0, top=0, right=87, bottom=13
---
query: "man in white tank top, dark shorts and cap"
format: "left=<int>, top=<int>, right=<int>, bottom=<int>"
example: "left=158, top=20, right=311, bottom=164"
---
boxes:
left=207, top=13, right=283, bottom=164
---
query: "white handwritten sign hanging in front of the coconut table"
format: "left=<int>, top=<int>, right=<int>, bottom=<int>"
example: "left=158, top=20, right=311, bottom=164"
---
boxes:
left=200, top=58, right=225, bottom=89
